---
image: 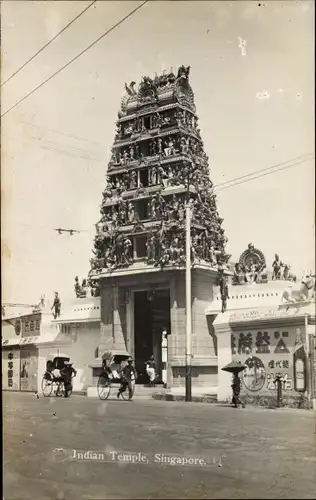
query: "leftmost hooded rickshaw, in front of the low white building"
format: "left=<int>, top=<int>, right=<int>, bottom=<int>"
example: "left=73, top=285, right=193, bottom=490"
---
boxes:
left=42, top=353, right=72, bottom=397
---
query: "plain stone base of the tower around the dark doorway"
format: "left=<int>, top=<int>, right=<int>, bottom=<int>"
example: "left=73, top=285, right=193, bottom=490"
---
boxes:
left=100, top=269, right=217, bottom=387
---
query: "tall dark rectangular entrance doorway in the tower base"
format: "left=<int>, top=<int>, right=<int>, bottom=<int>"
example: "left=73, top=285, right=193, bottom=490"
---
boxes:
left=134, top=289, right=170, bottom=384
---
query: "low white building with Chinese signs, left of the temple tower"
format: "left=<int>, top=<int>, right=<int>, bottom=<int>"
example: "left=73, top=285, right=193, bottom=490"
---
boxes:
left=2, top=297, right=100, bottom=392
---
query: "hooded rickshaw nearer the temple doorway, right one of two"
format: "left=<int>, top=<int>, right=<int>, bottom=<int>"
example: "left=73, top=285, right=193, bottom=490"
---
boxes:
left=97, top=350, right=135, bottom=401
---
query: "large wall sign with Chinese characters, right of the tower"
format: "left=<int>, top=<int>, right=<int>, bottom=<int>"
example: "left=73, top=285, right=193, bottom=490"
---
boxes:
left=231, top=327, right=307, bottom=395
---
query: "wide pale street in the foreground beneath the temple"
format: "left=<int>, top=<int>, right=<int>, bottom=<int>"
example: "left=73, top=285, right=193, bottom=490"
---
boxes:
left=3, top=392, right=316, bottom=500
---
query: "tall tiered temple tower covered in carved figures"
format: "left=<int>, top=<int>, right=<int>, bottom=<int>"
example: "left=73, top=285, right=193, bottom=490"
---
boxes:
left=89, top=66, right=229, bottom=386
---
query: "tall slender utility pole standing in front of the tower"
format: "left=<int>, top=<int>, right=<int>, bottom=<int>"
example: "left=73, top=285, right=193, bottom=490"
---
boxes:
left=185, top=200, right=192, bottom=401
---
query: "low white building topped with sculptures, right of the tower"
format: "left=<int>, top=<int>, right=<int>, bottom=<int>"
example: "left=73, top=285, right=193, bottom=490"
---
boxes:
left=206, top=246, right=316, bottom=405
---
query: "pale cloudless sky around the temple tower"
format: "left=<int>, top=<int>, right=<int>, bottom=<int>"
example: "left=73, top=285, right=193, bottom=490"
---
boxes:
left=1, top=0, right=315, bottom=304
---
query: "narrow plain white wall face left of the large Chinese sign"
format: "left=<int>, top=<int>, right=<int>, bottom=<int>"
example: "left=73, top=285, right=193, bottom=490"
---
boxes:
left=214, top=320, right=232, bottom=401
